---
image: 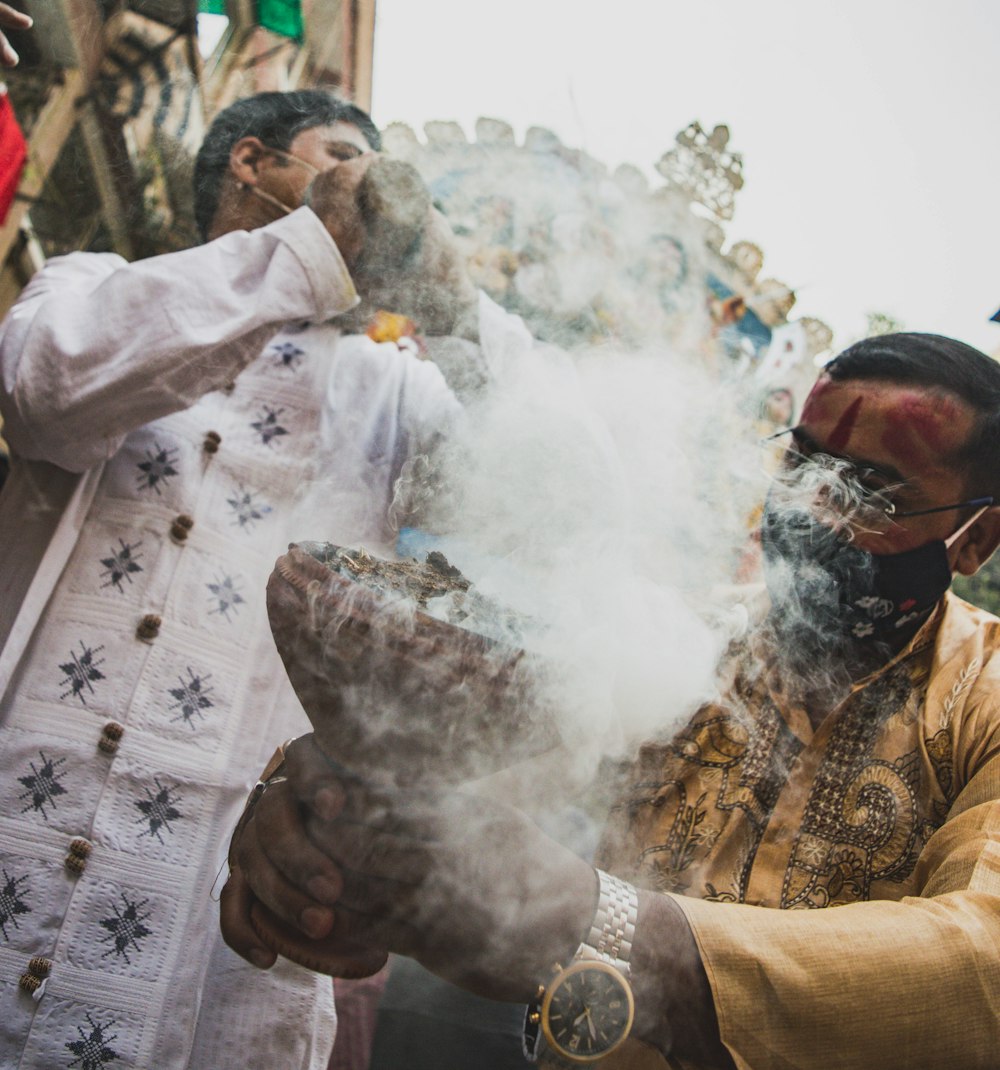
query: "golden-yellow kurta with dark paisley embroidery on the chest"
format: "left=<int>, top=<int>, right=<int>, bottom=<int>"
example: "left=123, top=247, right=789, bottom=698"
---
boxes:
left=601, top=595, right=1000, bottom=1070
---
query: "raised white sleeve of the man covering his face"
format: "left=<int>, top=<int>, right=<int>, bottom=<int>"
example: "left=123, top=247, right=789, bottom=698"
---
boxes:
left=0, top=209, right=357, bottom=472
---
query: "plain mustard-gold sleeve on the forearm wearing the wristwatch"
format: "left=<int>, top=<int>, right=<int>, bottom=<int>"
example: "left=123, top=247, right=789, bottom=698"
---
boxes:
left=674, top=891, right=1000, bottom=1070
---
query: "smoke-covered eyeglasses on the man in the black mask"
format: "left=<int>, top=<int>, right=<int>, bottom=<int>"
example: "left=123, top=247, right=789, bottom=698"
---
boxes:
left=760, top=427, right=994, bottom=534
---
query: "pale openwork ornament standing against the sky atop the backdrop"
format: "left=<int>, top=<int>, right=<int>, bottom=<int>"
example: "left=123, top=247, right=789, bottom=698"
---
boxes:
left=657, top=120, right=743, bottom=220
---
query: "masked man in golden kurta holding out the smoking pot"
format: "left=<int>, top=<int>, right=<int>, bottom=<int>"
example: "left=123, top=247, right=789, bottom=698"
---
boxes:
left=222, top=334, right=1000, bottom=1070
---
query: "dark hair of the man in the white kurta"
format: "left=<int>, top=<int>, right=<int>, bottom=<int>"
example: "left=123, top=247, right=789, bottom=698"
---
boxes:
left=195, top=89, right=382, bottom=239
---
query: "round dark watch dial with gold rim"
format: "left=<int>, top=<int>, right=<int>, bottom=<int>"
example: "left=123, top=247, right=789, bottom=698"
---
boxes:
left=541, top=962, right=634, bottom=1063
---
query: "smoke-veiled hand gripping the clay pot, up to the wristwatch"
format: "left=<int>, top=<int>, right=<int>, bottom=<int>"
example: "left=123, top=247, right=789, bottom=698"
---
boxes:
left=222, top=736, right=597, bottom=1000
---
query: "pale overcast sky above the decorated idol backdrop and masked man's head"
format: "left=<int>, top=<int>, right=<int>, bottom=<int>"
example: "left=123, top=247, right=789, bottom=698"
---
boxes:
left=372, top=0, right=1000, bottom=352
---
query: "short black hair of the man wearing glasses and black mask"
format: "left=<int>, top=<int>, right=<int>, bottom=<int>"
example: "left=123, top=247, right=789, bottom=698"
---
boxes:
left=825, top=333, right=1000, bottom=503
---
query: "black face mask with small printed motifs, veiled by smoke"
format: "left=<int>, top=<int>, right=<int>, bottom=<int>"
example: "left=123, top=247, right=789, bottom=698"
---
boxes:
left=760, top=500, right=952, bottom=648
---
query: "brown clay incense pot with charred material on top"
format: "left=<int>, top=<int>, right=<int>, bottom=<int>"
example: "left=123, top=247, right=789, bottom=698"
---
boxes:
left=253, top=544, right=558, bottom=976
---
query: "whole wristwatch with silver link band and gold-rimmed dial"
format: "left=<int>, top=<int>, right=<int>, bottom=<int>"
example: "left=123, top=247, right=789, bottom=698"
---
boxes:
left=523, top=870, right=639, bottom=1067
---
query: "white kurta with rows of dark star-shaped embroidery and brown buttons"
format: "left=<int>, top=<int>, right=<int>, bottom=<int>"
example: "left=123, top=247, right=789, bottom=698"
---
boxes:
left=0, top=210, right=459, bottom=1070
